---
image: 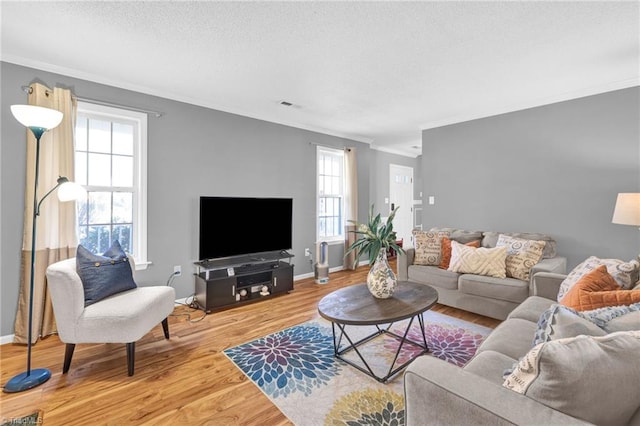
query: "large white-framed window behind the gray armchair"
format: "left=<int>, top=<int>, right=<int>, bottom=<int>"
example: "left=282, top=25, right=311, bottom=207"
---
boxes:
left=75, top=102, right=148, bottom=269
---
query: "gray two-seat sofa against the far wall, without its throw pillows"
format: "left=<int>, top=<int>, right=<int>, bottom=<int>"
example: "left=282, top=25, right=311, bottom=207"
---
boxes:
left=397, top=228, right=567, bottom=320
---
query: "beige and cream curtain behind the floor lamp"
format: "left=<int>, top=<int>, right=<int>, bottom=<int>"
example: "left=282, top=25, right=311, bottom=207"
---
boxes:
left=14, top=83, right=78, bottom=344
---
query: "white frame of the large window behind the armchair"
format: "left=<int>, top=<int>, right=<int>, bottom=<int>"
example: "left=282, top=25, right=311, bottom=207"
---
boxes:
left=74, top=101, right=151, bottom=270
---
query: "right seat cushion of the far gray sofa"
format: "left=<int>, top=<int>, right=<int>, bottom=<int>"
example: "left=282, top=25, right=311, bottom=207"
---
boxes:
left=458, top=274, right=529, bottom=303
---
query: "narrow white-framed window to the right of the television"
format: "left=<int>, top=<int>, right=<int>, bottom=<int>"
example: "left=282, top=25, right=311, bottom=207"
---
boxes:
left=317, top=146, right=344, bottom=241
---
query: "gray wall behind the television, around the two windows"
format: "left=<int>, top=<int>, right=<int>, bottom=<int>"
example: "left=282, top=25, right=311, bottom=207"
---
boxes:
left=0, top=62, right=416, bottom=336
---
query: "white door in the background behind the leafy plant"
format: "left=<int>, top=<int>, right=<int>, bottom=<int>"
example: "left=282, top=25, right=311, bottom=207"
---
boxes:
left=389, top=164, right=413, bottom=247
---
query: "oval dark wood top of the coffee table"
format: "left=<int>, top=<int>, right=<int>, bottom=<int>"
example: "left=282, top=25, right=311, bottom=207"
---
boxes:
left=318, top=281, right=438, bottom=325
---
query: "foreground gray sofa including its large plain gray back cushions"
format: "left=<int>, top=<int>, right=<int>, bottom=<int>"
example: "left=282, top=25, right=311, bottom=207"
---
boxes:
left=404, top=273, right=640, bottom=426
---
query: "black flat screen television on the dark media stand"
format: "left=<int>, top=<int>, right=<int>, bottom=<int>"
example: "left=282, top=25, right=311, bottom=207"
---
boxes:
left=199, top=196, right=293, bottom=261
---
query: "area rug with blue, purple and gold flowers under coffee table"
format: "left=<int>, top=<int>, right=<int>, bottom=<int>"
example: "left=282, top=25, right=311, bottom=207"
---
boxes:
left=224, top=311, right=491, bottom=426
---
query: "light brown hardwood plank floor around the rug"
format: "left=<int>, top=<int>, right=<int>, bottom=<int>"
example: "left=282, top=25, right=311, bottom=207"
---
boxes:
left=0, top=262, right=499, bottom=425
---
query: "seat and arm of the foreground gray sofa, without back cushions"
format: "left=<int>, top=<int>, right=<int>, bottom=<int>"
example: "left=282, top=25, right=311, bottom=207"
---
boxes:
left=404, top=273, right=640, bottom=426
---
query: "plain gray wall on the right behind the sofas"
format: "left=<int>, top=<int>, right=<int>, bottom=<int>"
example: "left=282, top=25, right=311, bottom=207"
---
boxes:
left=422, top=87, right=640, bottom=268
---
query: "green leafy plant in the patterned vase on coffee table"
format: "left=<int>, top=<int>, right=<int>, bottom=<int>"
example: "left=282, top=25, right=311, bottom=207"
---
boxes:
left=344, top=204, right=404, bottom=265
